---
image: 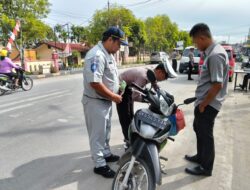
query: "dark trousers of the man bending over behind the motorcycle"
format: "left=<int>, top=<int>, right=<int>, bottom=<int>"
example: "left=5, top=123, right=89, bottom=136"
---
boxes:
left=116, top=86, right=134, bottom=140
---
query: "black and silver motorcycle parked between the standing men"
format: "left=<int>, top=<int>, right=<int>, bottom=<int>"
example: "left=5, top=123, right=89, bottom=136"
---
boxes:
left=112, top=71, right=196, bottom=190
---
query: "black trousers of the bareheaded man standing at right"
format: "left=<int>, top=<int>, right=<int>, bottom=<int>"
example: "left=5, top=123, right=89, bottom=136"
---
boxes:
left=193, top=106, right=218, bottom=171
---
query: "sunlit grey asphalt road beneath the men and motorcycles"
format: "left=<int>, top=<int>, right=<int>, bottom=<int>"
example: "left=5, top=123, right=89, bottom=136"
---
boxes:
left=0, top=66, right=250, bottom=190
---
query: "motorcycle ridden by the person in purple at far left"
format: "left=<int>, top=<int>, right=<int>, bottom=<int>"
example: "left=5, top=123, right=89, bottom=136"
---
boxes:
left=0, top=69, right=33, bottom=96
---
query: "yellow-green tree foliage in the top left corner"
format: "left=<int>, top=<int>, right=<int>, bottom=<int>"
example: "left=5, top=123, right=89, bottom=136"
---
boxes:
left=0, top=0, right=52, bottom=45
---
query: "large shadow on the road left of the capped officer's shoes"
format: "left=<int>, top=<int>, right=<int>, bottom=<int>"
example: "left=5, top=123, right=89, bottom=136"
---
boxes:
left=0, top=145, right=124, bottom=190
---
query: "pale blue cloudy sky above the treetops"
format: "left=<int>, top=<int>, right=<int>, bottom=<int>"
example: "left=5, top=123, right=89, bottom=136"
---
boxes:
left=45, top=0, right=250, bottom=43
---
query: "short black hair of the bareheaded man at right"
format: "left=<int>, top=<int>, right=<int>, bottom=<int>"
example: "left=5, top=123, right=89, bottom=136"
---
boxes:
left=189, top=23, right=212, bottom=38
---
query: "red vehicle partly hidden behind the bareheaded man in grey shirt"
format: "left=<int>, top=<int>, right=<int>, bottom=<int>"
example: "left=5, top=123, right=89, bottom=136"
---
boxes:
left=199, top=45, right=236, bottom=82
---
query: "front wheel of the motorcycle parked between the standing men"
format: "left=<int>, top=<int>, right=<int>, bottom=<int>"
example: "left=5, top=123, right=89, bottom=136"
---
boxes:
left=112, top=158, right=156, bottom=190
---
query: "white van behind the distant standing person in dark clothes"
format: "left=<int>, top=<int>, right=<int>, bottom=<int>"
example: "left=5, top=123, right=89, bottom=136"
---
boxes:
left=179, top=46, right=200, bottom=73
